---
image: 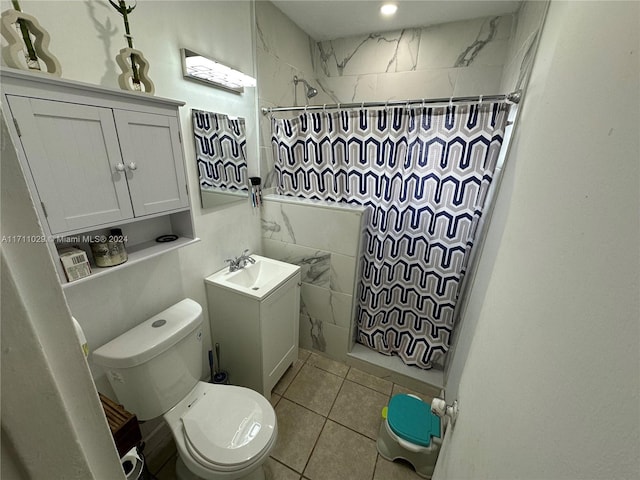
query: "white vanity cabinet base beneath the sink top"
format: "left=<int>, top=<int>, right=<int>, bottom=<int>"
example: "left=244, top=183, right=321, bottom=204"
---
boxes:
left=205, top=267, right=300, bottom=399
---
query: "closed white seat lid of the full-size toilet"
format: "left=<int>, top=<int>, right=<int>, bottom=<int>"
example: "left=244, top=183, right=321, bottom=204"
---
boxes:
left=181, top=386, right=276, bottom=469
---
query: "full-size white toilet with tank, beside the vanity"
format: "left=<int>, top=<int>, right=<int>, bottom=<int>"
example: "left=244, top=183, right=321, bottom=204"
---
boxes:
left=92, top=298, right=278, bottom=480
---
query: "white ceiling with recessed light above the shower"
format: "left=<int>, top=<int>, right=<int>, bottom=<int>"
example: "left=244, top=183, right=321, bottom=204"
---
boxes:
left=272, top=0, right=520, bottom=41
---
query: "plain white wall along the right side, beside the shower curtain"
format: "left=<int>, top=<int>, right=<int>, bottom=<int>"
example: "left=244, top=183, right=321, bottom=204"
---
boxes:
left=434, top=2, right=640, bottom=479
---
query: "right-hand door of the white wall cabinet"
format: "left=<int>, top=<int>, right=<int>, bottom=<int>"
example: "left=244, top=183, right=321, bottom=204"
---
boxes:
left=114, top=110, right=189, bottom=217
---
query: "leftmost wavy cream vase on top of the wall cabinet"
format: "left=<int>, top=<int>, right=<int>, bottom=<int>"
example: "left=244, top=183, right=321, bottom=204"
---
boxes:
left=0, top=0, right=62, bottom=77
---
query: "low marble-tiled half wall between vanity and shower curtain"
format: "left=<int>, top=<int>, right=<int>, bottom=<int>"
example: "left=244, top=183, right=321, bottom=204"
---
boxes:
left=262, top=197, right=365, bottom=361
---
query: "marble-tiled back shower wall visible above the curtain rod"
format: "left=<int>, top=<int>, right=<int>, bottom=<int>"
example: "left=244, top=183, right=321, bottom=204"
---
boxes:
left=314, top=15, right=512, bottom=104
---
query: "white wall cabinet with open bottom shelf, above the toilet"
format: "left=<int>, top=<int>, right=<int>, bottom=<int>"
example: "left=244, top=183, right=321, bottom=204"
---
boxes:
left=2, top=68, right=194, bottom=283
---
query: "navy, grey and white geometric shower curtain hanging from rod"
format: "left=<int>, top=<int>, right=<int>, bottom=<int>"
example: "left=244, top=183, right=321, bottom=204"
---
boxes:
left=272, top=102, right=509, bottom=368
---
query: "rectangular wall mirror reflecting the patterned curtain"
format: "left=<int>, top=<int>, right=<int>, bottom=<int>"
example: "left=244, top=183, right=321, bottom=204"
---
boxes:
left=191, top=110, right=248, bottom=190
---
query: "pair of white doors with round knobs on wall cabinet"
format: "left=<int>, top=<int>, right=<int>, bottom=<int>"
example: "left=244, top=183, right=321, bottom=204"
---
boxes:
left=9, top=96, right=189, bottom=234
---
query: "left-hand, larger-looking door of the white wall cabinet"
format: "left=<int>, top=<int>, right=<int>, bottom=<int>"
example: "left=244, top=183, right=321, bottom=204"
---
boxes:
left=8, top=96, right=133, bottom=234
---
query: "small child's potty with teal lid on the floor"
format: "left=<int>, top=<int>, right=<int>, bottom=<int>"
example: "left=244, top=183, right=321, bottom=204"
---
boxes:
left=376, top=393, right=442, bottom=478
